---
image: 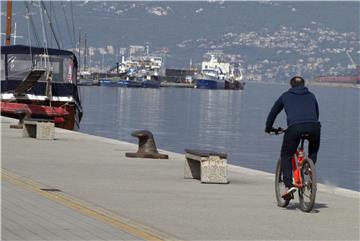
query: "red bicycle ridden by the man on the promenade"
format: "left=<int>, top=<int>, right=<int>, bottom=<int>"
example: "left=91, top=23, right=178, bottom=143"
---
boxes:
left=271, top=127, right=317, bottom=212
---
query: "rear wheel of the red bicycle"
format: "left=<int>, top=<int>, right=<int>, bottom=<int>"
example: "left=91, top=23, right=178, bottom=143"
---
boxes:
left=299, top=157, right=316, bottom=212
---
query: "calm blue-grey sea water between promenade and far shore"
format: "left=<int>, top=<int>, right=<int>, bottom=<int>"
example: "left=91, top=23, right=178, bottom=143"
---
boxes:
left=80, top=83, right=360, bottom=191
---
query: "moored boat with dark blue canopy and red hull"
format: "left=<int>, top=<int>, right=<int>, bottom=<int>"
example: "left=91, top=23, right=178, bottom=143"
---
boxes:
left=0, top=0, right=83, bottom=130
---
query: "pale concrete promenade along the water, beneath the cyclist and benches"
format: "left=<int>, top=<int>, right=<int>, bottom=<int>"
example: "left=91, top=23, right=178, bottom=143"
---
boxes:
left=1, top=117, right=360, bottom=240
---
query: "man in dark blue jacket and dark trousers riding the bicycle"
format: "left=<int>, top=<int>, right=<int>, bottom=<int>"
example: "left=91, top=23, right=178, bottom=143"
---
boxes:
left=265, top=76, right=321, bottom=199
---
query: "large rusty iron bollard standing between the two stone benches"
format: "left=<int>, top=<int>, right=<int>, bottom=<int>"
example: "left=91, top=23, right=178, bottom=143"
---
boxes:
left=125, top=130, right=169, bottom=159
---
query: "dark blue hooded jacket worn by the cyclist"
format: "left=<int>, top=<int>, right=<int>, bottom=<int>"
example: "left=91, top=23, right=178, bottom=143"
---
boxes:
left=266, top=86, right=319, bottom=129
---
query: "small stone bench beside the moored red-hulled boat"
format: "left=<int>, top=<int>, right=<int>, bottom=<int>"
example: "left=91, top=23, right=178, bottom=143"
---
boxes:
left=23, top=119, right=55, bottom=140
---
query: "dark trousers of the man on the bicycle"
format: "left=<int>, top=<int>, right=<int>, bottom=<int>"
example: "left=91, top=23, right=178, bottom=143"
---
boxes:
left=281, top=122, right=321, bottom=187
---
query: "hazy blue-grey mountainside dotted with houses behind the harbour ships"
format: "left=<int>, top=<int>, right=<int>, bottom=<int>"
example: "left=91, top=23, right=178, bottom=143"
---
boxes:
left=1, top=1, right=360, bottom=80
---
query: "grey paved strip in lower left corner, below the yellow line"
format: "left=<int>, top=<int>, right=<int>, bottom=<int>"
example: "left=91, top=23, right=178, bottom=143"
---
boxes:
left=1, top=181, right=139, bottom=240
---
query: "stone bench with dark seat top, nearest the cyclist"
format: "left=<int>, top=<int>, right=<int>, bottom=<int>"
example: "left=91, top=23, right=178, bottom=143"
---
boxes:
left=184, top=149, right=228, bottom=183
